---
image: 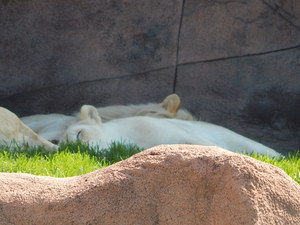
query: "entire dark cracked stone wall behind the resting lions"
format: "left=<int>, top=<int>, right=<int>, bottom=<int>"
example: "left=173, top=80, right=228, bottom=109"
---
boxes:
left=0, top=0, right=300, bottom=152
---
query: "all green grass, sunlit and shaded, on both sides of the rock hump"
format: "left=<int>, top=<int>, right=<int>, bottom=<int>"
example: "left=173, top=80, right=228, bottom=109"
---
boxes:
left=0, top=142, right=300, bottom=183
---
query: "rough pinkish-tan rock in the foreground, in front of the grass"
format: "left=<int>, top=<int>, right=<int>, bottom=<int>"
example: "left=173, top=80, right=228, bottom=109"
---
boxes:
left=0, top=145, right=300, bottom=225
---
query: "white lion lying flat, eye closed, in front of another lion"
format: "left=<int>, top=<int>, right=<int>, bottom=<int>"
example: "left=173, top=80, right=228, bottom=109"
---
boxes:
left=63, top=105, right=279, bottom=156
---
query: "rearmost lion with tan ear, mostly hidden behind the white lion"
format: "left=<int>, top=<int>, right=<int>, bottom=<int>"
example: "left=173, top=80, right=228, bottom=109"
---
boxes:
left=21, top=94, right=195, bottom=142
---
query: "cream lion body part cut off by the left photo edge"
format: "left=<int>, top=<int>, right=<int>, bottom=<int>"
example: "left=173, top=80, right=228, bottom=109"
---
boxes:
left=0, top=107, right=57, bottom=150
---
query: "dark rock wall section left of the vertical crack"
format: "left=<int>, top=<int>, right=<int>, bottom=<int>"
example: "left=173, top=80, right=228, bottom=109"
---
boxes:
left=0, top=0, right=181, bottom=114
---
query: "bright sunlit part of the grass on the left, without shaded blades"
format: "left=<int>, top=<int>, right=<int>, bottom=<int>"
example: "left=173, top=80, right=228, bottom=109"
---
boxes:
left=0, top=151, right=108, bottom=177
